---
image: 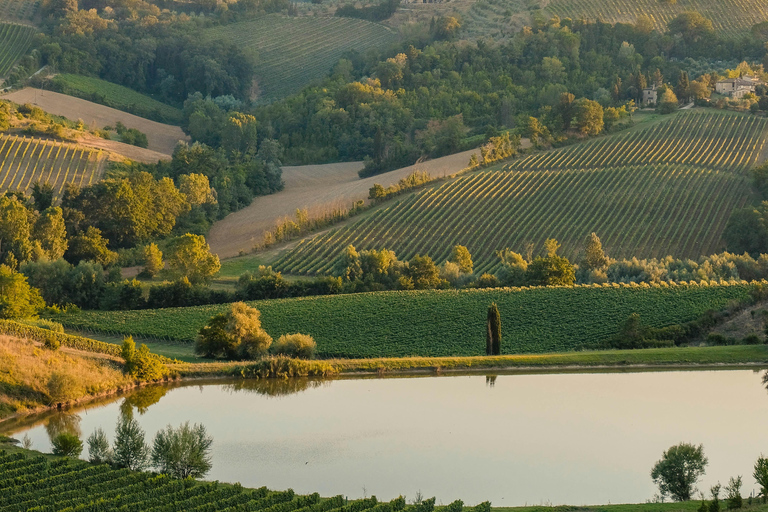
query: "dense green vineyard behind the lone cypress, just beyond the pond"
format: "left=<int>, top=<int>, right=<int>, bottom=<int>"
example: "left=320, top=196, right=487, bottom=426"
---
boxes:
left=55, top=282, right=751, bottom=358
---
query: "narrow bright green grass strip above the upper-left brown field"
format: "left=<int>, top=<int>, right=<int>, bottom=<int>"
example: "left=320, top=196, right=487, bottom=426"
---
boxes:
left=53, top=73, right=182, bottom=124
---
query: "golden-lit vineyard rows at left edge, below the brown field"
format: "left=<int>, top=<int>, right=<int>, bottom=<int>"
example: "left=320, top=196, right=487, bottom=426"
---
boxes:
left=0, top=135, right=105, bottom=199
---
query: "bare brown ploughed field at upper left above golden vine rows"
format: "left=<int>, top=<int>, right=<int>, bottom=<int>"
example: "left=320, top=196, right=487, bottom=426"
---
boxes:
left=2, top=87, right=189, bottom=155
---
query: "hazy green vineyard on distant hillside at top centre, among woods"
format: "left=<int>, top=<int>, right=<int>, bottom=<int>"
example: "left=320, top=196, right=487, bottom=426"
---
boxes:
left=201, top=15, right=398, bottom=100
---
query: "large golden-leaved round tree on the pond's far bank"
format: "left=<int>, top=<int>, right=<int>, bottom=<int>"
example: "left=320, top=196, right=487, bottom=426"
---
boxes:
left=195, top=302, right=272, bottom=359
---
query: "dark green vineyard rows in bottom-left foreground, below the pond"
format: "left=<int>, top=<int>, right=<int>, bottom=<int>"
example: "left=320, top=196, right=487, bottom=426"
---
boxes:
left=0, top=451, right=432, bottom=512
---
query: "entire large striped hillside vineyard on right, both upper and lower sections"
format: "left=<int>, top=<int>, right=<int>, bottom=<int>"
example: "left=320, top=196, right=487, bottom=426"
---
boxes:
left=274, top=112, right=767, bottom=275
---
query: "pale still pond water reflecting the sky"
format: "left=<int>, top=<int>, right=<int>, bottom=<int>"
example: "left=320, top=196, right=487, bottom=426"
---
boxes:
left=3, top=370, right=768, bottom=506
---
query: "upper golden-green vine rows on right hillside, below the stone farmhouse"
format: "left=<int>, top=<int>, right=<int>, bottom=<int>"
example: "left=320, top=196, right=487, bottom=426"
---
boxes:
left=507, top=112, right=768, bottom=172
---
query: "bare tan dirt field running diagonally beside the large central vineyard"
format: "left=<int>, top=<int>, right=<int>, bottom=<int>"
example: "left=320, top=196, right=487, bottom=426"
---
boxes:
left=208, top=150, right=479, bottom=258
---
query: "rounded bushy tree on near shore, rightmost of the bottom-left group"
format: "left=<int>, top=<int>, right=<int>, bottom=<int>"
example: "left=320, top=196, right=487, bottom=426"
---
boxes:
left=152, top=422, right=213, bottom=478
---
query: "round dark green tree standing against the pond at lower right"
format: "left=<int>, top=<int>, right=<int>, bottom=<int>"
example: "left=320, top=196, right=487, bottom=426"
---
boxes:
left=651, top=443, right=708, bottom=501
